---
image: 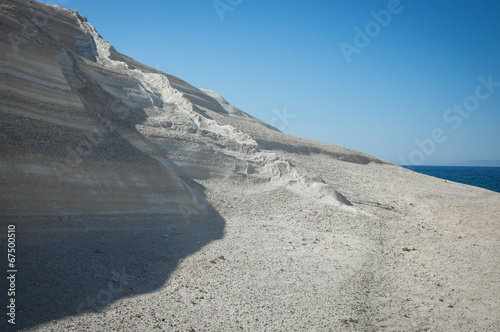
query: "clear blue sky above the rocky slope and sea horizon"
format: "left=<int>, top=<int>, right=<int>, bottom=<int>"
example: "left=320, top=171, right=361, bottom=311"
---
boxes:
left=51, top=0, right=500, bottom=164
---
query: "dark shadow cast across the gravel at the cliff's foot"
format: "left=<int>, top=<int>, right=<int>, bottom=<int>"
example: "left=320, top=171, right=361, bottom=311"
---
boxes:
left=1, top=192, right=225, bottom=330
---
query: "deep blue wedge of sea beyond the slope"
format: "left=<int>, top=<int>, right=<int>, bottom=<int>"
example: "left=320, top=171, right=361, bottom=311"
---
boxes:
left=403, top=166, right=500, bottom=193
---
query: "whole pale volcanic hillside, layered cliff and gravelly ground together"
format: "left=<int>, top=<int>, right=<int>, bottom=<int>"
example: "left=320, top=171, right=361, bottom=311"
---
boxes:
left=0, top=0, right=500, bottom=331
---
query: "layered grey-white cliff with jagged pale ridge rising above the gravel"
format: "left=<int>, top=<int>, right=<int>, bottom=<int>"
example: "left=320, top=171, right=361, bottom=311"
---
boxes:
left=0, top=1, right=372, bottom=214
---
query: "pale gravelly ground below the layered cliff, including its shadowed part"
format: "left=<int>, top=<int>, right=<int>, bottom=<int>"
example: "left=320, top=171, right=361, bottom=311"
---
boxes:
left=1, top=166, right=500, bottom=331
